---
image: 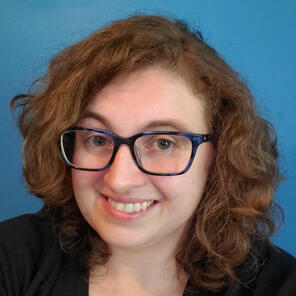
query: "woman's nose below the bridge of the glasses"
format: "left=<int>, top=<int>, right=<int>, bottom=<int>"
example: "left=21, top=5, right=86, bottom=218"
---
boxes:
left=104, top=145, right=147, bottom=194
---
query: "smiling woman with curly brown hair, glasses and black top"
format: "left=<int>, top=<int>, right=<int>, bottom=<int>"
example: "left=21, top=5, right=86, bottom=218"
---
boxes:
left=0, top=15, right=296, bottom=296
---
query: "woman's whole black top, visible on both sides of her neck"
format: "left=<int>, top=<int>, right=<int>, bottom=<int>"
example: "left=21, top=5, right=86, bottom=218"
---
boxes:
left=0, top=212, right=296, bottom=296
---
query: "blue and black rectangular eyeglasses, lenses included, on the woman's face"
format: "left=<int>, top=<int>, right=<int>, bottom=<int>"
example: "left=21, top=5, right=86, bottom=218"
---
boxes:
left=60, top=127, right=211, bottom=176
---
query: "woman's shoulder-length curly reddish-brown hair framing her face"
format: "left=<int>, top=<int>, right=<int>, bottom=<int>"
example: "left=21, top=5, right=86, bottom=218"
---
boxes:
left=11, top=15, right=281, bottom=291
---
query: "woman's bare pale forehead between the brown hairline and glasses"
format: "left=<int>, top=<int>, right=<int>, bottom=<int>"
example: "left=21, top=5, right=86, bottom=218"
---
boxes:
left=84, top=67, right=208, bottom=134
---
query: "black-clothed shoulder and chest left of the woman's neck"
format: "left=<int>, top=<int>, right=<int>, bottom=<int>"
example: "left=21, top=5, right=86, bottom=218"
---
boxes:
left=0, top=209, right=88, bottom=296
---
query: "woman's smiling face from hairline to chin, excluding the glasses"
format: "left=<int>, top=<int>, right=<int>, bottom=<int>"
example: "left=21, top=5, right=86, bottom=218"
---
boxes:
left=72, top=67, right=213, bottom=249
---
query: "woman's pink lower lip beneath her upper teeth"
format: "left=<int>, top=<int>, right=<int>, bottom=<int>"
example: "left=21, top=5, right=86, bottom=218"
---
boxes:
left=102, top=198, right=158, bottom=221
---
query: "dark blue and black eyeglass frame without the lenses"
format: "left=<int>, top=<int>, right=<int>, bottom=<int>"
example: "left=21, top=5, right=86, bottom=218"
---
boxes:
left=60, top=127, right=212, bottom=176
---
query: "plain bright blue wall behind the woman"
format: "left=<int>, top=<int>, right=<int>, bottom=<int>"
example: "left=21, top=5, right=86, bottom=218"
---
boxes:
left=0, top=0, right=296, bottom=255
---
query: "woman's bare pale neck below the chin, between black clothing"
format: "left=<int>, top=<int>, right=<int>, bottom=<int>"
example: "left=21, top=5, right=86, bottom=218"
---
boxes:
left=92, top=240, right=188, bottom=295
